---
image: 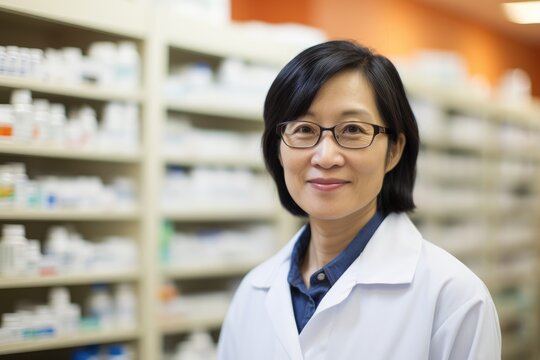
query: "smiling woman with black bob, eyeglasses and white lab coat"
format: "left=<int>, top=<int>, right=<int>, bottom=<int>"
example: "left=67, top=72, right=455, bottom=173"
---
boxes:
left=219, top=41, right=501, bottom=360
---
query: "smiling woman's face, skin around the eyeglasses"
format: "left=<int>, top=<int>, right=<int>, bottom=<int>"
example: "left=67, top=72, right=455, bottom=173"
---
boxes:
left=280, top=70, right=404, bottom=220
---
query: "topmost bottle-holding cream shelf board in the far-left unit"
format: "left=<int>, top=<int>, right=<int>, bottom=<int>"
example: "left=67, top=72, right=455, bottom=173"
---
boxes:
left=0, top=76, right=142, bottom=102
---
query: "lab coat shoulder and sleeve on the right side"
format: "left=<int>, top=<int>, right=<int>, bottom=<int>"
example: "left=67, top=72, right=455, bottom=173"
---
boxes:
left=418, top=240, right=501, bottom=359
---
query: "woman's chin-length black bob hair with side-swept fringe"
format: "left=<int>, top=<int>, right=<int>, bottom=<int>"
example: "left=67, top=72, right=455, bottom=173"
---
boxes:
left=262, top=40, right=420, bottom=216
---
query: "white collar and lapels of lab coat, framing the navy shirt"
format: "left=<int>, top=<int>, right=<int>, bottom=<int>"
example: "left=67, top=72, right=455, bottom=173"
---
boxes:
left=250, top=214, right=421, bottom=359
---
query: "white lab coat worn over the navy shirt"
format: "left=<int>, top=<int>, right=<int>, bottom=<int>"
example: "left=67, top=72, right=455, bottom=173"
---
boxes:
left=218, top=214, right=501, bottom=360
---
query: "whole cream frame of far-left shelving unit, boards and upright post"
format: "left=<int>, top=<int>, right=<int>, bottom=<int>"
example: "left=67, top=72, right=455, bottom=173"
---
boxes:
left=0, top=4, right=152, bottom=359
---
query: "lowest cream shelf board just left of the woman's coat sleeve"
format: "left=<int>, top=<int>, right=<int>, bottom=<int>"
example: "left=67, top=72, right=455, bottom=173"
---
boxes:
left=161, top=308, right=226, bottom=335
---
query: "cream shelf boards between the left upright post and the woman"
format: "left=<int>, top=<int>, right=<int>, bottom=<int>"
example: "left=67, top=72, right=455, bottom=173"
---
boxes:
left=153, top=14, right=299, bottom=358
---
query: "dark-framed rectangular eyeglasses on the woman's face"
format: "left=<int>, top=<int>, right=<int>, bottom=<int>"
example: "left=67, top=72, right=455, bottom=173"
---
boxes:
left=276, top=121, right=392, bottom=149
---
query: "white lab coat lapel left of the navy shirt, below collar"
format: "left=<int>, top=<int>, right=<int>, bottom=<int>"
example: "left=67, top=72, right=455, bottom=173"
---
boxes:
left=266, top=261, right=302, bottom=360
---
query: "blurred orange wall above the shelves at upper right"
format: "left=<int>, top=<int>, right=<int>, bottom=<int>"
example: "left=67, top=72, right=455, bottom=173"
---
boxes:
left=231, top=0, right=540, bottom=97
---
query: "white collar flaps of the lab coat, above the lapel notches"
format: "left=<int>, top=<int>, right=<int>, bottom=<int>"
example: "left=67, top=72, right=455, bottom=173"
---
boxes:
left=251, top=213, right=422, bottom=288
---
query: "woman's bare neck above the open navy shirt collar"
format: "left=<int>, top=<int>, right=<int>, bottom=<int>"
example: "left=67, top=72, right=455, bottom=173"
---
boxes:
left=302, top=207, right=376, bottom=286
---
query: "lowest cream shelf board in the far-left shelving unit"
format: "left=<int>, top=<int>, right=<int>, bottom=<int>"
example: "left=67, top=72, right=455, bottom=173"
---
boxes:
left=0, top=330, right=140, bottom=355
